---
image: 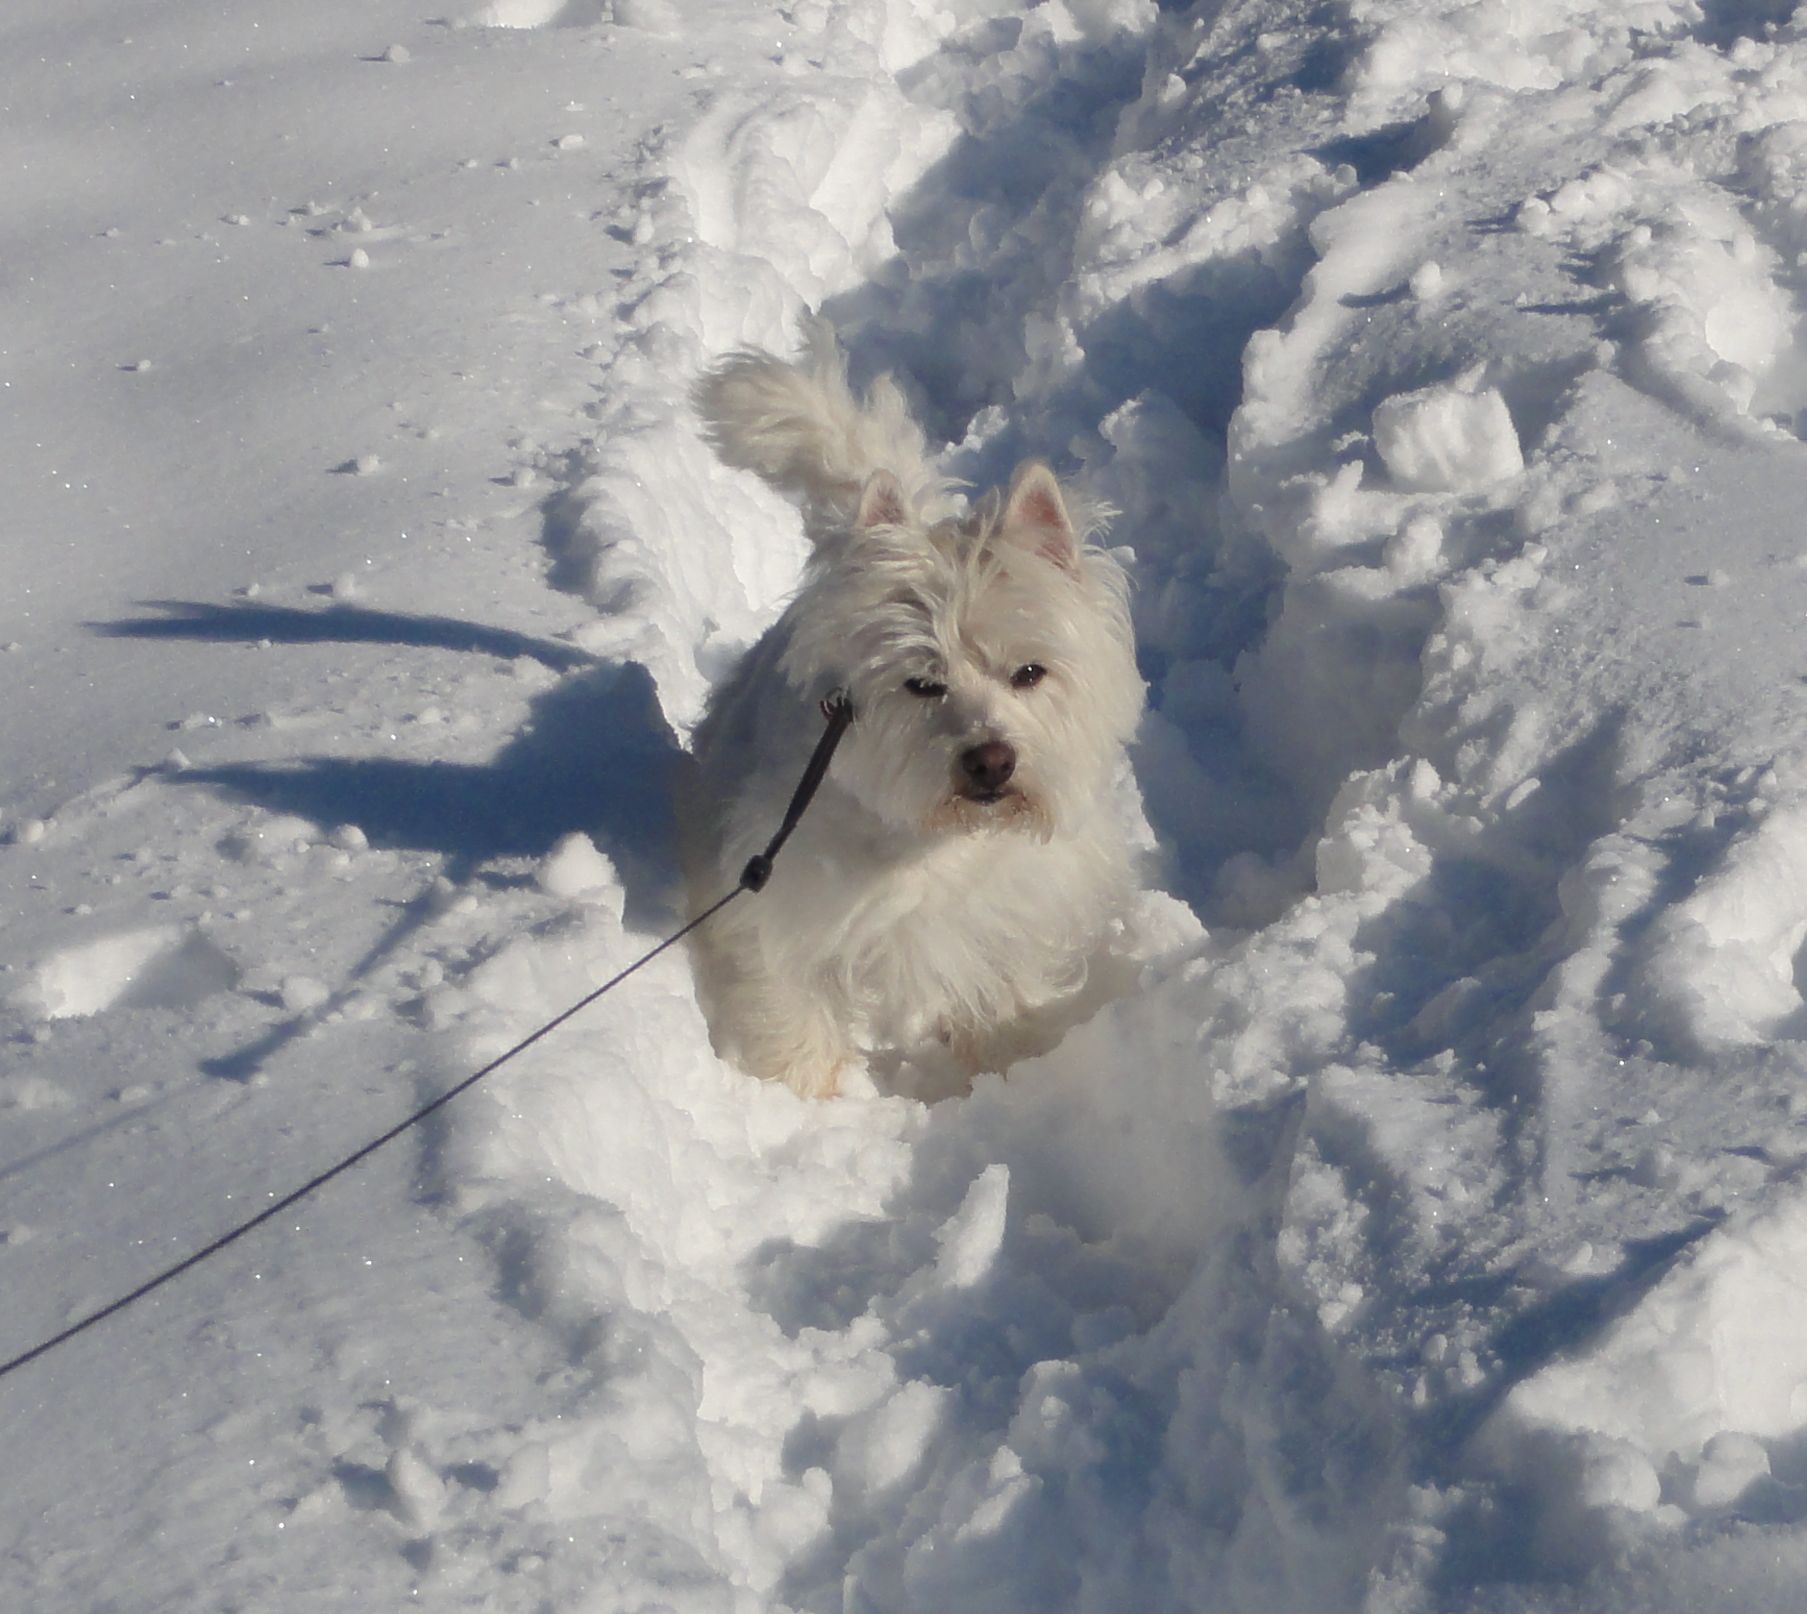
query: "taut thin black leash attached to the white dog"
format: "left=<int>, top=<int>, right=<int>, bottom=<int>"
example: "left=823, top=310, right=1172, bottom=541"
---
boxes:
left=0, top=690, right=853, bottom=1379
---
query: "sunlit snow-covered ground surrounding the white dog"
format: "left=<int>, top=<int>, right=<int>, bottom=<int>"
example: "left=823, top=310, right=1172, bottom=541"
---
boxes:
left=10, top=0, right=1807, bottom=1614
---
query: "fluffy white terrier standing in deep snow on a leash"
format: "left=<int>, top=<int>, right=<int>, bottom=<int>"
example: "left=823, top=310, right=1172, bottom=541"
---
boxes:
left=679, top=325, right=1142, bottom=1097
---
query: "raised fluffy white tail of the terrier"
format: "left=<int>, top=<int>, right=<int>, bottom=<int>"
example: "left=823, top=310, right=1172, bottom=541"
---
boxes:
left=694, top=320, right=950, bottom=539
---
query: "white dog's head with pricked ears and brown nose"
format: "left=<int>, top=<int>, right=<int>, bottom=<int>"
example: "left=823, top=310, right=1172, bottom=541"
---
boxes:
left=784, top=463, right=1142, bottom=837
